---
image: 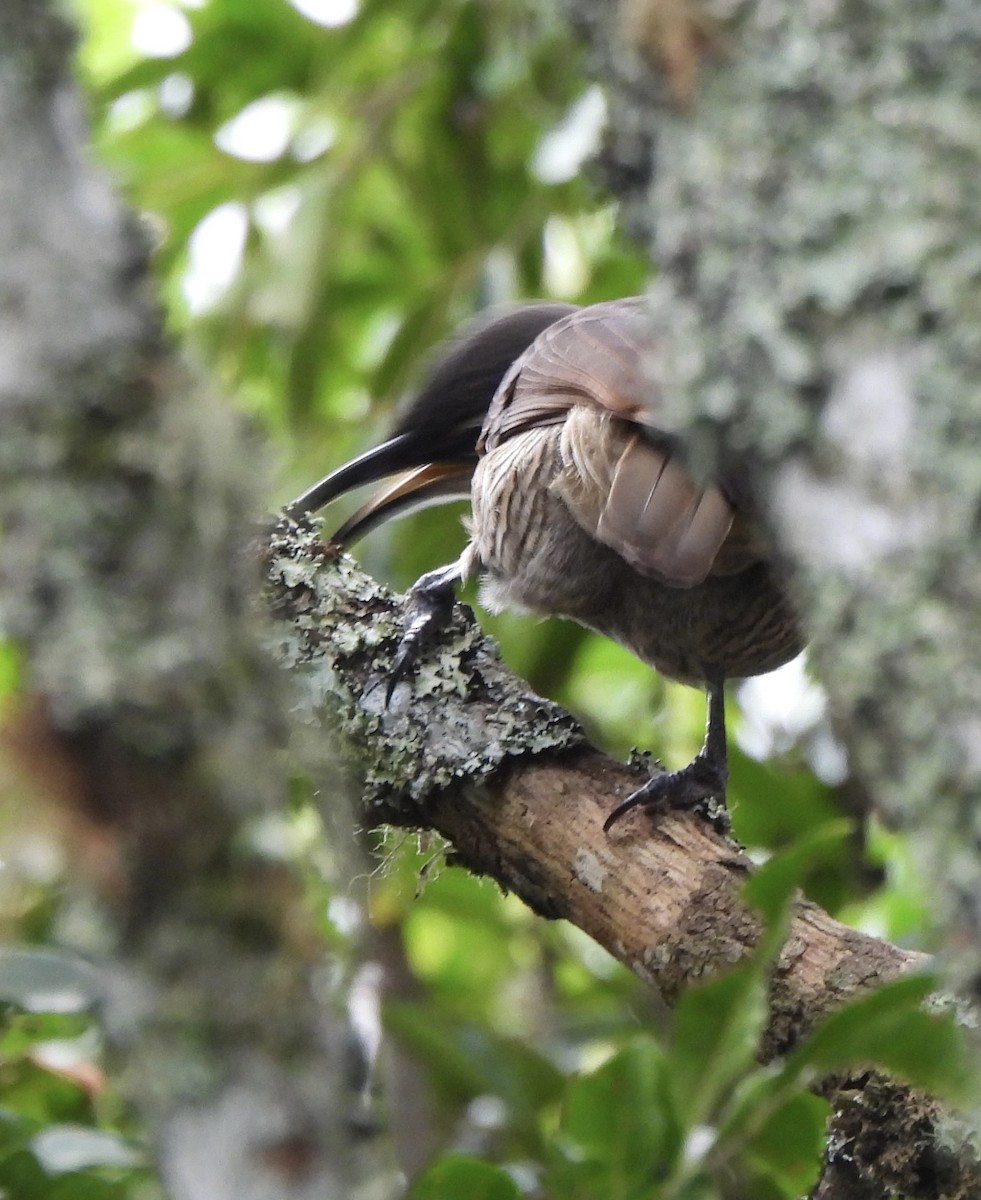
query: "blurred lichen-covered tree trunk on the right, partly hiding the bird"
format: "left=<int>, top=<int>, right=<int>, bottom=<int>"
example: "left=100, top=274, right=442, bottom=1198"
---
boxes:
left=565, top=0, right=981, bottom=990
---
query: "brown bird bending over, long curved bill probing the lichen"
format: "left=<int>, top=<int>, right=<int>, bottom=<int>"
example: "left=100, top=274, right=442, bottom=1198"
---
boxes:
left=287, top=296, right=802, bottom=829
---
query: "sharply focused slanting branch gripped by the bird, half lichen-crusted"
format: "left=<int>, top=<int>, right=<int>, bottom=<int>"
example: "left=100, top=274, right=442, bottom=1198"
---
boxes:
left=267, top=521, right=981, bottom=1198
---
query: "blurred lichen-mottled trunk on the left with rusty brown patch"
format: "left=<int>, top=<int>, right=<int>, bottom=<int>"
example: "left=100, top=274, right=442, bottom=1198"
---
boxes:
left=0, top=0, right=387, bottom=1200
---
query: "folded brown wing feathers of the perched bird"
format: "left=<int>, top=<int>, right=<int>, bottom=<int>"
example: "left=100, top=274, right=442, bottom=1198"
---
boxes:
left=481, top=296, right=759, bottom=587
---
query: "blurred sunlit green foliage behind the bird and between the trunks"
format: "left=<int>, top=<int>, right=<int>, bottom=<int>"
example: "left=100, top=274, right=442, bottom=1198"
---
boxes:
left=0, top=0, right=957, bottom=1200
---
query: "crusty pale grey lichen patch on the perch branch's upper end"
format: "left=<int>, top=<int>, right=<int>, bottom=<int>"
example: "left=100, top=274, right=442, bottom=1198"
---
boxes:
left=269, top=523, right=584, bottom=820
